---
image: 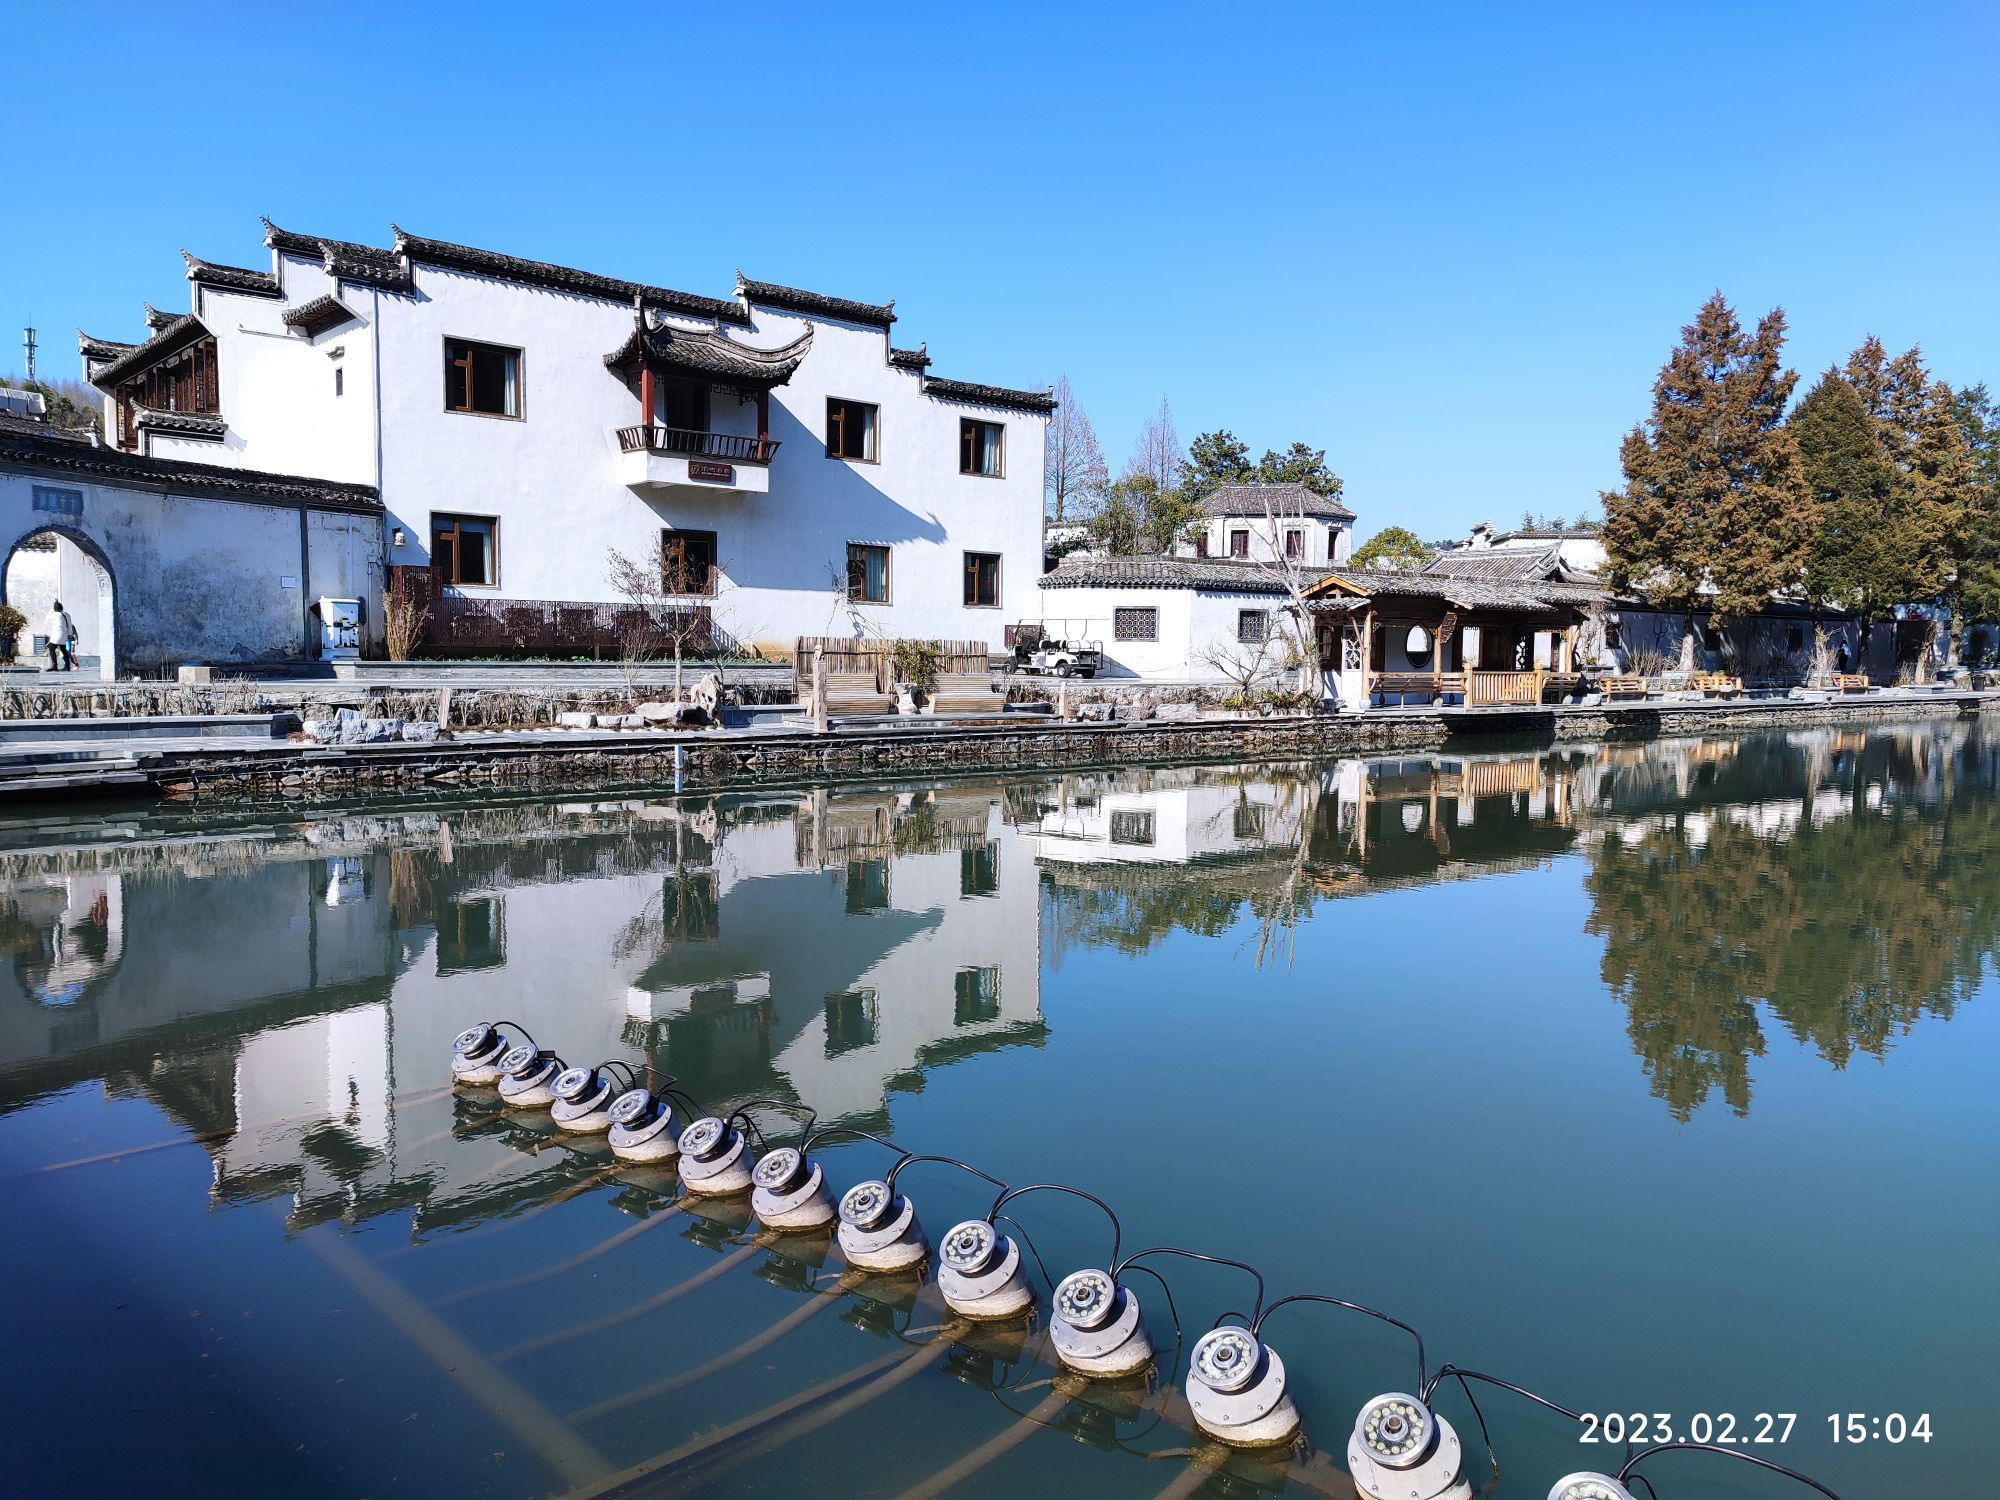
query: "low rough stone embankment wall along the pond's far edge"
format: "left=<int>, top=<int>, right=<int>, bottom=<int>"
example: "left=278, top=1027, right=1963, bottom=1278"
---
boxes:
left=3, top=692, right=2000, bottom=800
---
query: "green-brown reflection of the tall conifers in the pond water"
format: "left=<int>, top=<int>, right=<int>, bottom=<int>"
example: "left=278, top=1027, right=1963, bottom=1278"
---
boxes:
left=1586, top=732, right=2000, bottom=1120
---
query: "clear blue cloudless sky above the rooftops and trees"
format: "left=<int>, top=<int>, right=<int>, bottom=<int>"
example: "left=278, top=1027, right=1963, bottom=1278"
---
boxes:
left=0, top=0, right=2000, bottom=536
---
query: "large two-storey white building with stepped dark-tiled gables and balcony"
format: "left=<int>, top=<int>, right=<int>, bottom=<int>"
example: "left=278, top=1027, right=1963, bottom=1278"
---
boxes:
left=80, top=220, right=1054, bottom=652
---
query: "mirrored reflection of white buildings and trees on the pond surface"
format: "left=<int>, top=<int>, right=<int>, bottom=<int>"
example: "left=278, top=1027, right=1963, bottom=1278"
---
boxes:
left=0, top=724, right=2000, bottom=1232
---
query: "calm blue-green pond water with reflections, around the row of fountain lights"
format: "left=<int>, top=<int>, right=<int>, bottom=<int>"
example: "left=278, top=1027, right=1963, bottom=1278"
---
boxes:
left=0, top=724, right=2000, bottom=1500
